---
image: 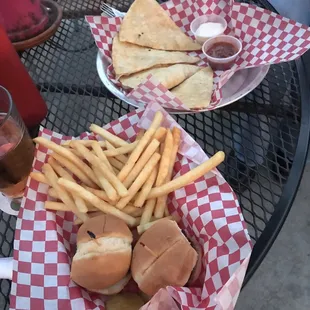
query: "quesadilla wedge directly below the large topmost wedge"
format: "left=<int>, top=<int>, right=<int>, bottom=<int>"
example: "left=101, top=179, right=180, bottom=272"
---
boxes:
left=112, top=35, right=200, bottom=76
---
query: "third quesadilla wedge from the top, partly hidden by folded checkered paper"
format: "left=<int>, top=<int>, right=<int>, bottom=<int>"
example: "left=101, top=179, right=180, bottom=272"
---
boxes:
left=120, top=64, right=200, bottom=89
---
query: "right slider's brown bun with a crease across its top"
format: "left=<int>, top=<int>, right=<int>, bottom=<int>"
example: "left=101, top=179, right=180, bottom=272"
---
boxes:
left=131, top=219, right=197, bottom=296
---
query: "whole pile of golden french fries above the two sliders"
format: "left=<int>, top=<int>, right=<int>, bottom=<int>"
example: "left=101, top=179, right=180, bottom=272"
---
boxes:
left=30, top=112, right=225, bottom=234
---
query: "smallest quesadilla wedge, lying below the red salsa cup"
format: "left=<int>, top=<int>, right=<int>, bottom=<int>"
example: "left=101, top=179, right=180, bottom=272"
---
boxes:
left=171, top=67, right=213, bottom=109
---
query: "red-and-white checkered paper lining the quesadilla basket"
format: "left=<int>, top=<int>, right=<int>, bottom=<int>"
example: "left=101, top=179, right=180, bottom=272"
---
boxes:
left=86, top=0, right=310, bottom=110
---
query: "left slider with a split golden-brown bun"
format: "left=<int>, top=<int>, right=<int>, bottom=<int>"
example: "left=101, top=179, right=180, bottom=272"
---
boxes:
left=71, top=215, right=132, bottom=291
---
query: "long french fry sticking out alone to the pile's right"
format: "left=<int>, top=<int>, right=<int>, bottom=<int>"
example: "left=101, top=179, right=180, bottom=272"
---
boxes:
left=148, top=151, right=225, bottom=199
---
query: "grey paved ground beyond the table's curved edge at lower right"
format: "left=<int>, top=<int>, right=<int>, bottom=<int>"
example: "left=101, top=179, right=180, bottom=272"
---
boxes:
left=236, top=164, right=310, bottom=310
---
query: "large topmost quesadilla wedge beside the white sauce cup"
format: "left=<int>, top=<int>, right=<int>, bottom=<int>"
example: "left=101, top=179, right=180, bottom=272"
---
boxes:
left=119, top=0, right=201, bottom=51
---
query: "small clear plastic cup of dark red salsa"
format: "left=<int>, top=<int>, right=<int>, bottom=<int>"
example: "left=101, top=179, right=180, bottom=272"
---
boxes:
left=202, top=35, right=242, bottom=70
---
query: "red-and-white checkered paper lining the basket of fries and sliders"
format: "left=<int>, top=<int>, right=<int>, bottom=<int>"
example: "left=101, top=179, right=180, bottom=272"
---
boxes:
left=10, top=103, right=251, bottom=310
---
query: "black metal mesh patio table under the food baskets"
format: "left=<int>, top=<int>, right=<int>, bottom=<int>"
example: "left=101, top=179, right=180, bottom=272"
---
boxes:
left=0, top=0, right=310, bottom=309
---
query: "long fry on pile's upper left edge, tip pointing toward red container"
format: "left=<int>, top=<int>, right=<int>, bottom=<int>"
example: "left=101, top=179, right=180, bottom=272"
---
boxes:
left=34, top=137, right=98, bottom=186
